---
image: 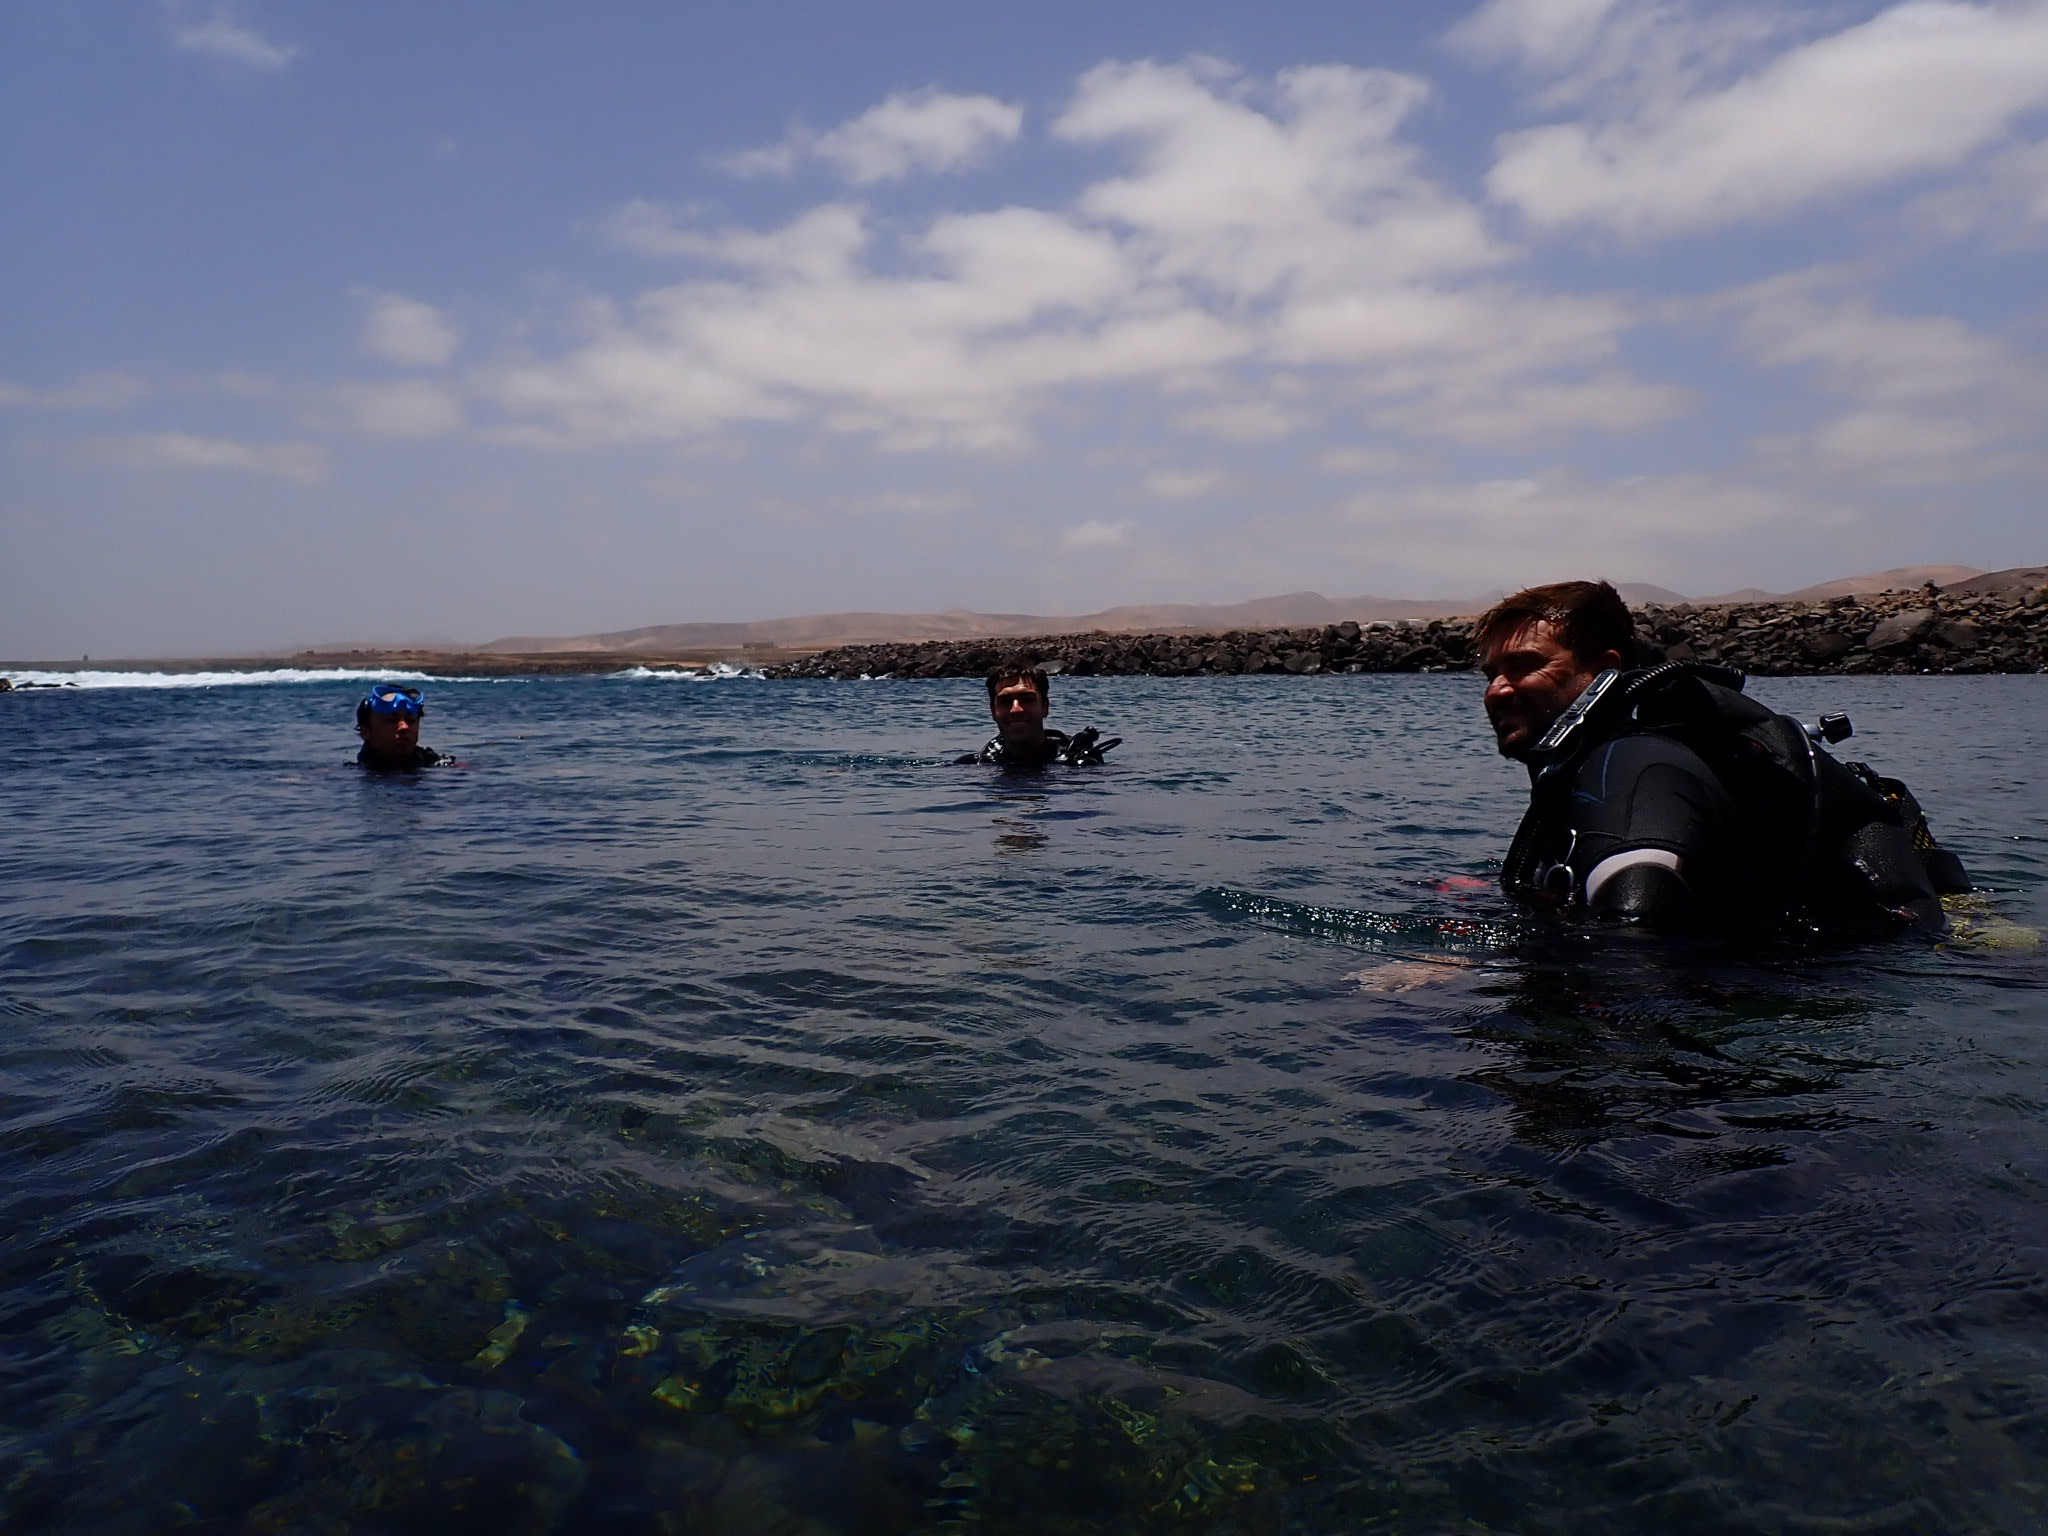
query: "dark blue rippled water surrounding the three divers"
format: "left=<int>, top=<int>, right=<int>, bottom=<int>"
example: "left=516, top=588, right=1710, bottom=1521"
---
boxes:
left=0, top=678, right=2048, bottom=1536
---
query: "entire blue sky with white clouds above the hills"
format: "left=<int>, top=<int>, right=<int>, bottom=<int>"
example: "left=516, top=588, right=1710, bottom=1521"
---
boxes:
left=0, top=0, right=2048, bottom=657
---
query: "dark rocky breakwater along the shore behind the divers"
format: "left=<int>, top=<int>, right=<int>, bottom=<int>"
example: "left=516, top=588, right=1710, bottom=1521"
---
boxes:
left=768, top=588, right=2048, bottom=678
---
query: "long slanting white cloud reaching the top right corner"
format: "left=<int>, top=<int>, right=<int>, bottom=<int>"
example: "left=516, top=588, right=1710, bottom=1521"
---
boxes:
left=1487, top=0, right=2048, bottom=238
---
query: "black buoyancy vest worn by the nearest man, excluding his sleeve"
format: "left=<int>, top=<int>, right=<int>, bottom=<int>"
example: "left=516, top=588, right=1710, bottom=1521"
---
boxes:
left=1501, top=662, right=1970, bottom=934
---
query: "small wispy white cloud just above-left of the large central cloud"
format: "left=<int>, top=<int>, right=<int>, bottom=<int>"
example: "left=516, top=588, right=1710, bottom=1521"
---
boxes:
left=725, top=90, right=1024, bottom=186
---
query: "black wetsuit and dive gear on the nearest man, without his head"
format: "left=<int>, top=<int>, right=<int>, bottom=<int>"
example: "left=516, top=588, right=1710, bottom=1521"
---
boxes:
left=1501, top=668, right=1968, bottom=936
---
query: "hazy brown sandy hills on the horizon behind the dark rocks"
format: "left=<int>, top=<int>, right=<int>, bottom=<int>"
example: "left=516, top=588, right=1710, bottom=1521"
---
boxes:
left=479, top=565, right=1998, bottom=655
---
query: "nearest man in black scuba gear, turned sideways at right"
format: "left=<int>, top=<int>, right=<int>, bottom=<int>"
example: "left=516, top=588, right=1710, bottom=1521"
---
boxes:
left=1475, top=582, right=1970, bottom=938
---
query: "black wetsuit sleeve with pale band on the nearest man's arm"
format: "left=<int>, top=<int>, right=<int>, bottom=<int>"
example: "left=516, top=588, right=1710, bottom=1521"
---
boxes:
left=1565, top=735, right=1741, bottom=928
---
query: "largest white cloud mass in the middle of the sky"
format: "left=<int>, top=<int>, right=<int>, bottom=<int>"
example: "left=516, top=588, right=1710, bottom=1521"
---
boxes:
left=487, top=61, right=1677, bottom=453
